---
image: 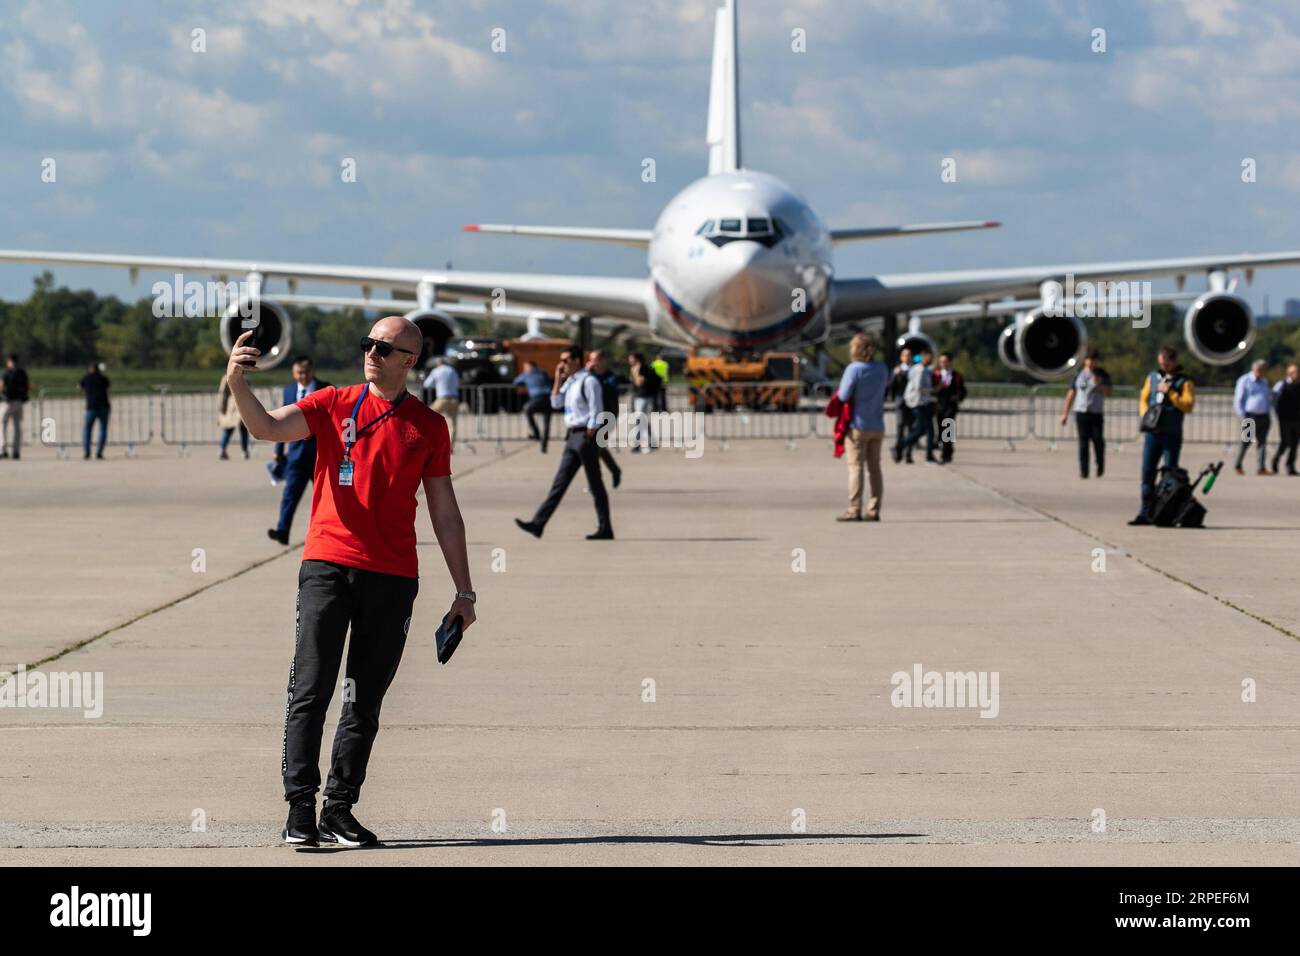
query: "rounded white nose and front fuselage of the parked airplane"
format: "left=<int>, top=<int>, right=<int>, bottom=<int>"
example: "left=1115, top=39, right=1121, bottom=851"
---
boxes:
left=649, top=170, right=832, bottom=351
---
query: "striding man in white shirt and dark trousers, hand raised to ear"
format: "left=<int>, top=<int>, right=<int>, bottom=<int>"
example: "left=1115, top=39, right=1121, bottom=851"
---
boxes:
left=515, top=346, right=614, bottom=541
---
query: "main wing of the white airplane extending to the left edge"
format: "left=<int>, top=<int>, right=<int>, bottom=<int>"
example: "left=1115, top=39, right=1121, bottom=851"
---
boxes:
left=0, top=250, right=650, bottom=323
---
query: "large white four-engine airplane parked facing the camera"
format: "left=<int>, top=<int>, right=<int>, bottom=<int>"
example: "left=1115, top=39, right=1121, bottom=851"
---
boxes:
left=0, top=0, right=1300, bottom=378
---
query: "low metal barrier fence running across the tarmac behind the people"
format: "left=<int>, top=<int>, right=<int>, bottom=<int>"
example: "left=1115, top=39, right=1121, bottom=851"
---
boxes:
left=23, top=382, right=1240, bottom=455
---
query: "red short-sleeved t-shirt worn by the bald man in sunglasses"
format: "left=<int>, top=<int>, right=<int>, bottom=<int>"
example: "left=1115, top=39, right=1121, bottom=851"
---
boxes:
left=298, top=384, right=451, bottom=578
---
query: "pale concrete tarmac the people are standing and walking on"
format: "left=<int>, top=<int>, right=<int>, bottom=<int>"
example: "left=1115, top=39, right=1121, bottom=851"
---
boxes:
left=0, top=429, right=1300, bottom=865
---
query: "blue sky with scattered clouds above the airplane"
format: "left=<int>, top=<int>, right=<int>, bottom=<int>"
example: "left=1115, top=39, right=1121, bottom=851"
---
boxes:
left=0, top=0, right=1300, bottom=311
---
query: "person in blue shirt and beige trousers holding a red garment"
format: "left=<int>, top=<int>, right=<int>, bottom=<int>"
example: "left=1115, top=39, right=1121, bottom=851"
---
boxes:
left=836, top=332, right=889, bottom=522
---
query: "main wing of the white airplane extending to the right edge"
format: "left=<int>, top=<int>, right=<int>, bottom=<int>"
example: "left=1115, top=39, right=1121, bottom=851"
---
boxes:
left=831, top=251, right=1300, bottom=324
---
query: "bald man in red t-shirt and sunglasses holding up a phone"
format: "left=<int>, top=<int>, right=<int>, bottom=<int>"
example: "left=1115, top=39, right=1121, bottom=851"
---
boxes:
left=226, top=316, right=475, bottom=847
